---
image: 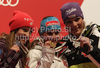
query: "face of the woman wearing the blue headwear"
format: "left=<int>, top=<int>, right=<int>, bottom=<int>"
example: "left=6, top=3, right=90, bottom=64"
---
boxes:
left=42, top=30, right=60, bottom=43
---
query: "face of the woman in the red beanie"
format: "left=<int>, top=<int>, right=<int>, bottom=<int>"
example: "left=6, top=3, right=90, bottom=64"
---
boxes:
left=15, top=27, right=32, bottom=44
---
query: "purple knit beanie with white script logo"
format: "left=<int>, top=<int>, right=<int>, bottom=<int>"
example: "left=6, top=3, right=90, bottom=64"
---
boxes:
left=60, top=2, right=84, bottom=24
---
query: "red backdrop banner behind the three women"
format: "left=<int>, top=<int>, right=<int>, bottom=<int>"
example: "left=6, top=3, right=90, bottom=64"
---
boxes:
left=0, top=0, right=89, bottom=40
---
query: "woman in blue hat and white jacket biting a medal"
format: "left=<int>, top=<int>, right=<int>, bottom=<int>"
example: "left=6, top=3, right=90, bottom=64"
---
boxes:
left=26, top=16, right=67, bottom=68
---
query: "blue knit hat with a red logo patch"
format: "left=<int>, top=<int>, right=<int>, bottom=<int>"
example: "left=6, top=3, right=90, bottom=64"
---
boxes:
left=39, top=17, right=61, bottom=35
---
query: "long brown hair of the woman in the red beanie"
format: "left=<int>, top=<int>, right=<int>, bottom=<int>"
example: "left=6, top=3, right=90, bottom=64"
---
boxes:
left=0, top=29, right=31, bottom=66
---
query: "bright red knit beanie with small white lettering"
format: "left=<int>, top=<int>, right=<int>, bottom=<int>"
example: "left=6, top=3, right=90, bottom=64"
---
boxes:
left=9, top=11, right=34, bottom=32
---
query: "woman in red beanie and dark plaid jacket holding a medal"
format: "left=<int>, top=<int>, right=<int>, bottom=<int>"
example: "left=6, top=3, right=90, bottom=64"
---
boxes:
left=0, top=11, right=33, bottom=68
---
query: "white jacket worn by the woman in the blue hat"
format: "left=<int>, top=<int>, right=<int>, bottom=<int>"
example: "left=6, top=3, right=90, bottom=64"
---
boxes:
left=26, top=45, right=68, bottom=68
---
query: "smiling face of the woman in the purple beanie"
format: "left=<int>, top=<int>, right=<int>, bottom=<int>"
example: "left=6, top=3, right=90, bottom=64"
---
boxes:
left=65, top=17, right=85, bottom=37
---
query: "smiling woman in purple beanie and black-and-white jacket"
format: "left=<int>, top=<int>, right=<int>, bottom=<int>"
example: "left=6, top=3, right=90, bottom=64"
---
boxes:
left=60, top=2, right=100, bottom=68
